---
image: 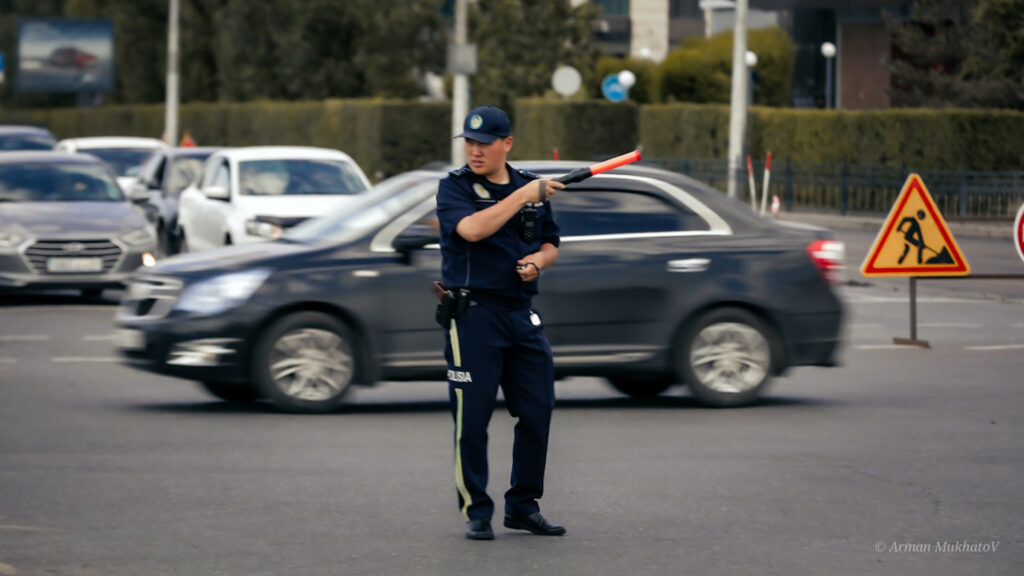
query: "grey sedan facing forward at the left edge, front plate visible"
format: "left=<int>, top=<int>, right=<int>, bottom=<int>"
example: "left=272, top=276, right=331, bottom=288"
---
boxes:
left=0, top=152, right=157, bottom=295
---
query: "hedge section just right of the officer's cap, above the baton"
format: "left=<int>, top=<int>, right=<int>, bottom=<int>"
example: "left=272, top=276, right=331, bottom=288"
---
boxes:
left=512, top=98, right=639, bottom=161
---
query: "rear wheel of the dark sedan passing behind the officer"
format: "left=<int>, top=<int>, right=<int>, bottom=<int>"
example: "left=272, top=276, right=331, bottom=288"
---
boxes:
left=676, top=307, right=779, bottom=407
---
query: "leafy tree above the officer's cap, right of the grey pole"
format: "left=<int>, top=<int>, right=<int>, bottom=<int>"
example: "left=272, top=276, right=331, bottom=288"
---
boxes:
left=470, top=0, right=599, bottom=112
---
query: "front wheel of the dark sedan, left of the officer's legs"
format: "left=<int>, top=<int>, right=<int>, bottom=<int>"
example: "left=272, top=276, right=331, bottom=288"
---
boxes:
left=252, top=312, right=357, bottom=413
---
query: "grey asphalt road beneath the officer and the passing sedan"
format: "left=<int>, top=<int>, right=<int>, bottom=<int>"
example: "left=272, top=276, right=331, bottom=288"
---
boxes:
left=0, top=233, right=1024, bottom=576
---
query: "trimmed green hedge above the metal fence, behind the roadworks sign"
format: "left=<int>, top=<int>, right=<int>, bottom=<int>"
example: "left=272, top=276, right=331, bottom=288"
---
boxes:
left=639, top=104, right=1024, bottom=170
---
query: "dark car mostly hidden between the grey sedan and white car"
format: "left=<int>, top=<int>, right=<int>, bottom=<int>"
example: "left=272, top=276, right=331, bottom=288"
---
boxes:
left=132, top=148, right=220, bottom=255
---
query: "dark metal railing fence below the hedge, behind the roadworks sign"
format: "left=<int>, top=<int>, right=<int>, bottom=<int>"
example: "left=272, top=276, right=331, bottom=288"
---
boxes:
left=643, top=158, right=1024, bottom=219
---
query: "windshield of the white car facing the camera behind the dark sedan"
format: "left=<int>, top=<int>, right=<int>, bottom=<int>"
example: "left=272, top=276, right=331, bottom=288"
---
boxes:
left=239, top=160, right=367, bottom=196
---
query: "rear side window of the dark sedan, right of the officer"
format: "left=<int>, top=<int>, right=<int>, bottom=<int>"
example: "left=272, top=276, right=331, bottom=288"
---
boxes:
left=551, top=190, right=711, bottom=237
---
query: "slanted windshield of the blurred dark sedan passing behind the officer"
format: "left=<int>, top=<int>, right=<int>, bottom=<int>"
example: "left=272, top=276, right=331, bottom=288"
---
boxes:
left=285, top=172, right=437, bottom=244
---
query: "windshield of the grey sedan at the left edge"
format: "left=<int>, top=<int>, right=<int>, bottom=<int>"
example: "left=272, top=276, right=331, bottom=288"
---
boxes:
left=0, top=163, right=125, bottom=202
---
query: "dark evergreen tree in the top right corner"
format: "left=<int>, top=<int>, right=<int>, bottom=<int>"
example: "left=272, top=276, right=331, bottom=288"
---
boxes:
left=886, top=0, right=1024, bottom=109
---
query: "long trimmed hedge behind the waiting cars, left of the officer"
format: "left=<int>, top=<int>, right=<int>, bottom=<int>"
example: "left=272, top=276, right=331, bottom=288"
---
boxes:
left=0, top=99, right=452, bottom=177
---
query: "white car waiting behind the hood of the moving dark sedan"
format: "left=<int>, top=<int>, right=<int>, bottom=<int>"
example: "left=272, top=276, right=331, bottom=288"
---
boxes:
left=178, top=147, right=372, bottom=252
